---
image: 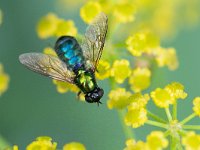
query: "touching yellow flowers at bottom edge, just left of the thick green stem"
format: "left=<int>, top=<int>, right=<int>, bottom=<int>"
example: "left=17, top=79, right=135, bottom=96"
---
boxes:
left=124, top=131, right=169, bottom=150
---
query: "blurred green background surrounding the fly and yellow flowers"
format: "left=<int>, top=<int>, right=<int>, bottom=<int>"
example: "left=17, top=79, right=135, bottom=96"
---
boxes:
left=0, top=0, right=200, bottom=150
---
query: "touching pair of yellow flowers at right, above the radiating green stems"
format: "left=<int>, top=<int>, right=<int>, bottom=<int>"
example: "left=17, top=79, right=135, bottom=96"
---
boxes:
left=151, top=82, right=187, bottom=108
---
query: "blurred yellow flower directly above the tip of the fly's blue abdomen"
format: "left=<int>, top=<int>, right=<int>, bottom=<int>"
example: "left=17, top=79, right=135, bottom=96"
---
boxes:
left=55, top=19, right=77, bottom=37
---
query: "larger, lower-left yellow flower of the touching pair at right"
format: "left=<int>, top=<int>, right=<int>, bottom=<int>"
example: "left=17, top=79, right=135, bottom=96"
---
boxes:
left=151, top=88, right=175, bottom=108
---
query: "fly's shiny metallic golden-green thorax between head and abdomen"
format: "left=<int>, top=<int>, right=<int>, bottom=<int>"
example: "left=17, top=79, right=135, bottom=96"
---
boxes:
left=74, top=70, right=97, bottom=94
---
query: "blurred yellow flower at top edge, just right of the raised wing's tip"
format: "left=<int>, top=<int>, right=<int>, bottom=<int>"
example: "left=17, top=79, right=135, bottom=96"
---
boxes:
left=113, top=2, right=136, bottom=23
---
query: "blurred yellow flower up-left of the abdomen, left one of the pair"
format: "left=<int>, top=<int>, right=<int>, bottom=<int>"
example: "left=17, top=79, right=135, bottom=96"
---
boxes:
left=37, top=13, right=60, bottom=39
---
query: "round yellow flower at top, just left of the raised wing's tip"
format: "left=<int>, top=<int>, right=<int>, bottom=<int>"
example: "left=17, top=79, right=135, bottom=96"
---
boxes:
left=80, top=1, right=102, bottom=23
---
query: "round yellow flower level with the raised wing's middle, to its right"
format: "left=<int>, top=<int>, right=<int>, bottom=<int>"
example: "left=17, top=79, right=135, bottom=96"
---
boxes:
left=126, top=33, right=146, bottom=56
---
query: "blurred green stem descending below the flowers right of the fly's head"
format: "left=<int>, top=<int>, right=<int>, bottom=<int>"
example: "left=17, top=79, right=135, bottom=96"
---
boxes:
left=118, top=110, right=135, bottom=139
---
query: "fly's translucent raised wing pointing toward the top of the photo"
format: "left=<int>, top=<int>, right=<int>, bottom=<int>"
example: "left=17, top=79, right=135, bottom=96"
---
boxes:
left=81, top=13, right=108, bottom=71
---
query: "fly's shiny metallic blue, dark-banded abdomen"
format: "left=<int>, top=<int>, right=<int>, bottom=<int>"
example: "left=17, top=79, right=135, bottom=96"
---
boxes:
left=55, top=36, right=84, bottom=71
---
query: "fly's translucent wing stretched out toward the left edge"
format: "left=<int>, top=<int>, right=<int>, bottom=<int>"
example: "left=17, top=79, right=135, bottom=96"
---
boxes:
left=19, top=53, right=75, bottom=83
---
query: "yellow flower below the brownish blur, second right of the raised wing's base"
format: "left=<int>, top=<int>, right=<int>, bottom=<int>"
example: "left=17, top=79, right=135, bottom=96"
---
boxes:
left=129, top=67, right=151, bottom=92
